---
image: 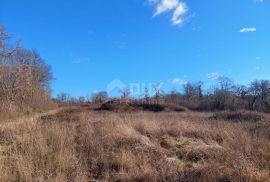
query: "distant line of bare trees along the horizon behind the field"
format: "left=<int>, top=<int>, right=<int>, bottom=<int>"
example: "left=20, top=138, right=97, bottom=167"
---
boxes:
left=56, top=76, right=270, bottom=112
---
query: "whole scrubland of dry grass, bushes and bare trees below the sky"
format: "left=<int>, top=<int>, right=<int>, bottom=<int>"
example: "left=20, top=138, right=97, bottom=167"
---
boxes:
left=0, top=22, right=270, bottom=182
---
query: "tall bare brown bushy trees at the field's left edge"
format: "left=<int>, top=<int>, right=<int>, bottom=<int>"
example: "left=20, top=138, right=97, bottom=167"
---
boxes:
left=0, top=26, right=53, bottom=115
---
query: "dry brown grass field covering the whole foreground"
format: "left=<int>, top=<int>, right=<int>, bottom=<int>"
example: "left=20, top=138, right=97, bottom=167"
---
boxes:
left=0, top=108, right=270, bottom=182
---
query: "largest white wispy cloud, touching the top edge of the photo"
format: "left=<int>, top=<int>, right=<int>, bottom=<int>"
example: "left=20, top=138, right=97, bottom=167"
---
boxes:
left=148, top=0, right=188, bottom=25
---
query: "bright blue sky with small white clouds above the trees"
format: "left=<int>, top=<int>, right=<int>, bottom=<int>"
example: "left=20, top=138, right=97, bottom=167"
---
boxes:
left=0, top=0, right=270, bottom=96
